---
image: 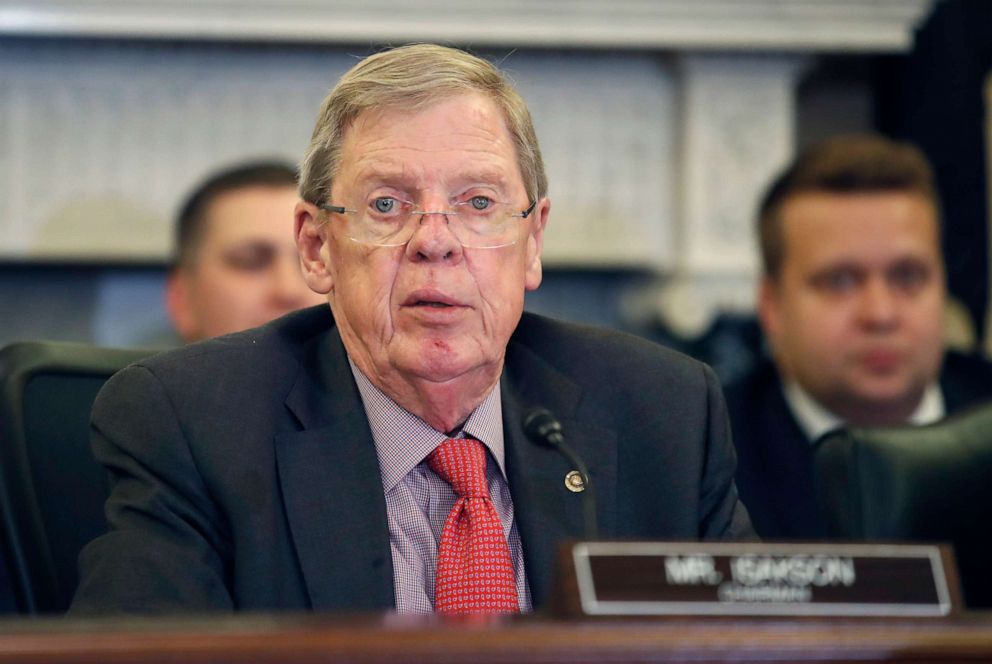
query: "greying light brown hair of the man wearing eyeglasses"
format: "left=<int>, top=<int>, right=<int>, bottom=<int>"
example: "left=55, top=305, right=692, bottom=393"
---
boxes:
left=300, top=44, right=548, bottom=205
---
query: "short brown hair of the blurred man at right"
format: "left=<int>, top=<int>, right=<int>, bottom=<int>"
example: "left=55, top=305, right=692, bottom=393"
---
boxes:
left=758, top=134, right=940, bottom=279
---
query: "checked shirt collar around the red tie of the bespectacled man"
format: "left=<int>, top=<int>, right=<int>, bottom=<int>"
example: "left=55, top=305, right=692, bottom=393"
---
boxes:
left=348, top=357, right=506, bottom=492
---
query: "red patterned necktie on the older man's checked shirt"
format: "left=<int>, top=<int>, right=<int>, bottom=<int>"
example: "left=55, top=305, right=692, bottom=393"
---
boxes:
left=427, top=438, right=519, bottom=614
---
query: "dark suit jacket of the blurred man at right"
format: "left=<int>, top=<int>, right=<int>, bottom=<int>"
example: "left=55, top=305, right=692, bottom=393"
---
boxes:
left=726, top=352, right=992, bottom=539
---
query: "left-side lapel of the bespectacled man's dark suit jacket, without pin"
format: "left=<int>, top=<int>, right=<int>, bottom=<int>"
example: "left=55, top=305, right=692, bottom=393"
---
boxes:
left=276, top=328, right=395, bottom=611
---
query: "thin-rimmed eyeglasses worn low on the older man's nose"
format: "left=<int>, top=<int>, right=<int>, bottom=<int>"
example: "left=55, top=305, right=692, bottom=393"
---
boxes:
left=318, top=196, right=537, bottom=249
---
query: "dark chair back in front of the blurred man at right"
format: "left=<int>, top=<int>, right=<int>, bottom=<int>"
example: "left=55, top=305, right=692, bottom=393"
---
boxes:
left=814, top=404, right=992, bottom=608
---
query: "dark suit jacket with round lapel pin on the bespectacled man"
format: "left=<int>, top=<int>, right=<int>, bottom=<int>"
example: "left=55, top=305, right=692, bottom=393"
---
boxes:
left=72, top=307, right=752, bottom=614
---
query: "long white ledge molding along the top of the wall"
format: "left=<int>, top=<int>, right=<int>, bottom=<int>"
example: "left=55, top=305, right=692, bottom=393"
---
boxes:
left=0, top=0, right=933, bottom=51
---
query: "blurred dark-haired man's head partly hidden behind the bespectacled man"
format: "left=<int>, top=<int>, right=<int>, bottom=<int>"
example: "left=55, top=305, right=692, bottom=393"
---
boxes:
left=166, top=162, right=324, bottom=342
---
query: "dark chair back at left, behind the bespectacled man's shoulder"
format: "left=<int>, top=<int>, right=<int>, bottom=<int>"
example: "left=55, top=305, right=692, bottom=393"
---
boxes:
left=0, top=341, right=154, bottom=614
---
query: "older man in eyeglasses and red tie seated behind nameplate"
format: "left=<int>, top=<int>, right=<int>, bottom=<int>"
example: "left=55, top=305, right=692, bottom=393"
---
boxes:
left=72, top=45, right=752, bottom=614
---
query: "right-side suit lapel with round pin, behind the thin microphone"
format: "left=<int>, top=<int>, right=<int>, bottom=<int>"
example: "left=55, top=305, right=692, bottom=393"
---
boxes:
left=501, top=349, right=616, bottom=608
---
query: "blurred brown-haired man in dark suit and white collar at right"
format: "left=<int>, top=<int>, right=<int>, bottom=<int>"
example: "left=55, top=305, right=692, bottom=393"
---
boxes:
left=726, top=136, right=992, bottom=538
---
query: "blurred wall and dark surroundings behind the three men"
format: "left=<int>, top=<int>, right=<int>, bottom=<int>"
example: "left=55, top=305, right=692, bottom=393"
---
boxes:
left=0, top=0, right=992, bottom=380
